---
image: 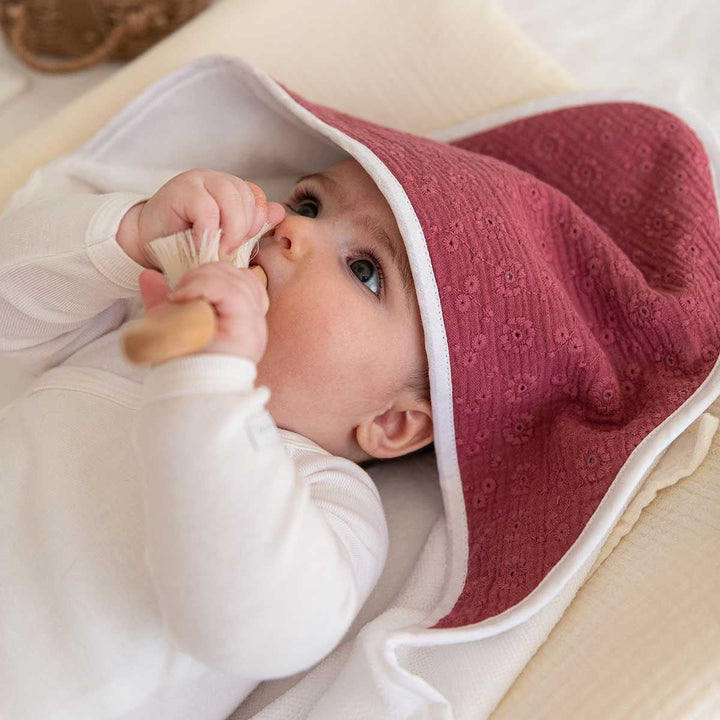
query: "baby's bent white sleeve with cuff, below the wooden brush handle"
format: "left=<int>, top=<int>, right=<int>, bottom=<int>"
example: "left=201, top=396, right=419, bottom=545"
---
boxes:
left=134, top=354, right=388, bottom=680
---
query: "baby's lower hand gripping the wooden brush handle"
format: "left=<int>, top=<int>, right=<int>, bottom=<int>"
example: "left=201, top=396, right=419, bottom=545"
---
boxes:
left=140, top=262, right=270, bottom=363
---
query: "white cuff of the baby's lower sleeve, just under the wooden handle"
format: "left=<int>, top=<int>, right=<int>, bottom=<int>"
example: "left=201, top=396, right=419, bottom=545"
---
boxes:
left=143, top=353, right=270, bottom=404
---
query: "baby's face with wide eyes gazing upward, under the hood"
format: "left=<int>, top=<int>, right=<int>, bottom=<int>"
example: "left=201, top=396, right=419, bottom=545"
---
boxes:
left=254, top=160, right=431, bottom=461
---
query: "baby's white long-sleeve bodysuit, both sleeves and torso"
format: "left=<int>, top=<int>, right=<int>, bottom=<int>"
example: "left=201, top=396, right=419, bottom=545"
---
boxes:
left=0, top=163, right=387, bottom=720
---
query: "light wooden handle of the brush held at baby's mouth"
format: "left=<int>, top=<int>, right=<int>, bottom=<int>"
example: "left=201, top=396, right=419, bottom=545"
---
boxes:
left=122, top=267, right=267, bottom=365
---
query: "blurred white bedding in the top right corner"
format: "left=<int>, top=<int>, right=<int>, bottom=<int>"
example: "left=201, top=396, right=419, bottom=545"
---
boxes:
left=498, top=0, right=720, bottom=133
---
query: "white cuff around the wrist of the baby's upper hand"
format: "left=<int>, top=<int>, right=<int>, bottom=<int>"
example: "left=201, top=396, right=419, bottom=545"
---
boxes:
left=85, top=192, right=149, bottom=293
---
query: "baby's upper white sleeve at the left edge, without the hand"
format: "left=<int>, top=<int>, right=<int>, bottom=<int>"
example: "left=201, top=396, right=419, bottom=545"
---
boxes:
left=0, top=168, right=147, bottom=373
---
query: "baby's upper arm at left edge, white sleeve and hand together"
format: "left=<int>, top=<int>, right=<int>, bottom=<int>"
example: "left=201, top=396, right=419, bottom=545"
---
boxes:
left=0, top=164, right=284, bottom=372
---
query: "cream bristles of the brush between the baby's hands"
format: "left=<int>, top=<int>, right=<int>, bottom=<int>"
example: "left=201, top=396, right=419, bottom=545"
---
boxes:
left=148, top=223, right=272, bottom=289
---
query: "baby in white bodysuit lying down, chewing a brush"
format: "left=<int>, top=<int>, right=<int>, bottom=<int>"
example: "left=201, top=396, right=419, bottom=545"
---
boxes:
left=0, top=160, right=433, bottom=720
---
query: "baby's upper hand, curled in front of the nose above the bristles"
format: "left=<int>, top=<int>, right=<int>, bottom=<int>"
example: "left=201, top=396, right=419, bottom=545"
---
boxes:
left=117, top=170, right=285, bottom=268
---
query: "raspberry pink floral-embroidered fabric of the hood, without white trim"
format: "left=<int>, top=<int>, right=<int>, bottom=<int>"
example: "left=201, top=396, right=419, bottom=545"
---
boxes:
left=280, top=93, right=720, bottom=628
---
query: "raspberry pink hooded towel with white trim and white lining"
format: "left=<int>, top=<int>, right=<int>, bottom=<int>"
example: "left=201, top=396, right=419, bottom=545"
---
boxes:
left=18, top=56, right=720, bottom=720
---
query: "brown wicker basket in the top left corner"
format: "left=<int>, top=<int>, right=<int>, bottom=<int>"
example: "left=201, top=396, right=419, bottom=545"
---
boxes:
left=0, top=0, right=211, bottom=72
